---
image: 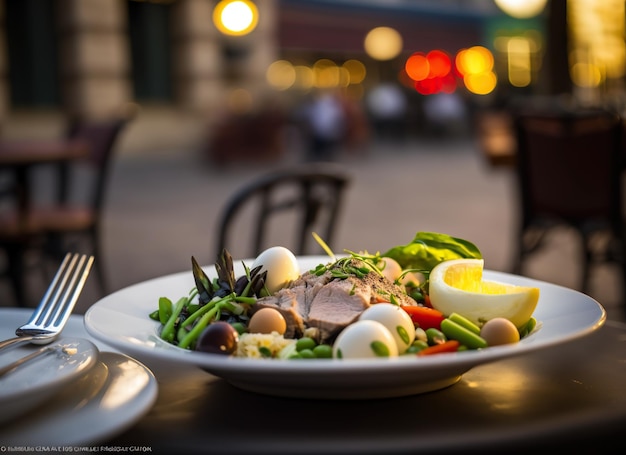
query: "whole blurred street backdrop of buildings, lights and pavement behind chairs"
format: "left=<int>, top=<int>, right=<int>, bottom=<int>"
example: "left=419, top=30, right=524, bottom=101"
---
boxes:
left=0, top=0, right=626, bottom=319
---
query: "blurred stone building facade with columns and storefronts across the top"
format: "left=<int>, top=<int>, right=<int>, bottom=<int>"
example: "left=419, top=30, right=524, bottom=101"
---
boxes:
left=0, top=0, right=624, bottom=156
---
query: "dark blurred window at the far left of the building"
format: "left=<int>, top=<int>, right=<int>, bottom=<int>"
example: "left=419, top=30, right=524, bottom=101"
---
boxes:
left=5, top=0, right=60, bottom=107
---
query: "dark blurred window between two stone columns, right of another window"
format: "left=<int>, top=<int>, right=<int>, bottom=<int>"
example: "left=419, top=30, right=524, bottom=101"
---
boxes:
left=128, top=1, right=172, bottom=102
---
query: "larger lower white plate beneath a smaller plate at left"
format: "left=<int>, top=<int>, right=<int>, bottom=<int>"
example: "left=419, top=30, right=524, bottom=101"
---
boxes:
left=0, top=309, right=158, bottom=446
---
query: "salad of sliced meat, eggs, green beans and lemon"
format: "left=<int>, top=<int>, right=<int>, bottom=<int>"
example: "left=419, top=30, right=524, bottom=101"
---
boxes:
left=149, top=232, right=539, bottom=361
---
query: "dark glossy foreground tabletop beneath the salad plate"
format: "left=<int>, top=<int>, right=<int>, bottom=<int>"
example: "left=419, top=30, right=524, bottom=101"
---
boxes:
left=108, top=322, right=626, bottom=454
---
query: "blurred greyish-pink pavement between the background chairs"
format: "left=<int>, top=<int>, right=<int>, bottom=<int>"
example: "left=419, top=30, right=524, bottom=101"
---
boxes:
left=0, top=138, right=626, bottom=320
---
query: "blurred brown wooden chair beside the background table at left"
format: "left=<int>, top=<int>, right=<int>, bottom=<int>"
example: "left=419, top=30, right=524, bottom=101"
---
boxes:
left=0, top=110, right=134, bottom=305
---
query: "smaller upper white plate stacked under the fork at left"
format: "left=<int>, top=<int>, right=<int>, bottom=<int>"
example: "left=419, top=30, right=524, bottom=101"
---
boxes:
left=0, top=337, right=99, bottom=424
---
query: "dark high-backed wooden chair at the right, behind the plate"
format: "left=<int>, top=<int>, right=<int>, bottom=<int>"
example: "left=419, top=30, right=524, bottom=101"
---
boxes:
left=513, top=104, right=626, bottom=304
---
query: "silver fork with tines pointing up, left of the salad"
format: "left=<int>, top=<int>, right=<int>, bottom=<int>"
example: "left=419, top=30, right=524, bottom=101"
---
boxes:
left=0, top=253, right=93, bottom=350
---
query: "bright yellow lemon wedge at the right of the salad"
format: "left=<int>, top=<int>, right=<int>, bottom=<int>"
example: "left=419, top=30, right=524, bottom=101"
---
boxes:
left=429, top=259, right=539, bottom=329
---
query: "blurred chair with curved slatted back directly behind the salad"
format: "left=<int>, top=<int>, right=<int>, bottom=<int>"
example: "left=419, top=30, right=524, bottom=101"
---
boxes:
left=215, top=163, right=350, bottom=257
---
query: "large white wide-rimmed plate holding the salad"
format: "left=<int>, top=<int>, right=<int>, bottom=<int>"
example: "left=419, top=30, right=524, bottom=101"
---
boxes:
left=85, top=256, right=606, bottom=398
